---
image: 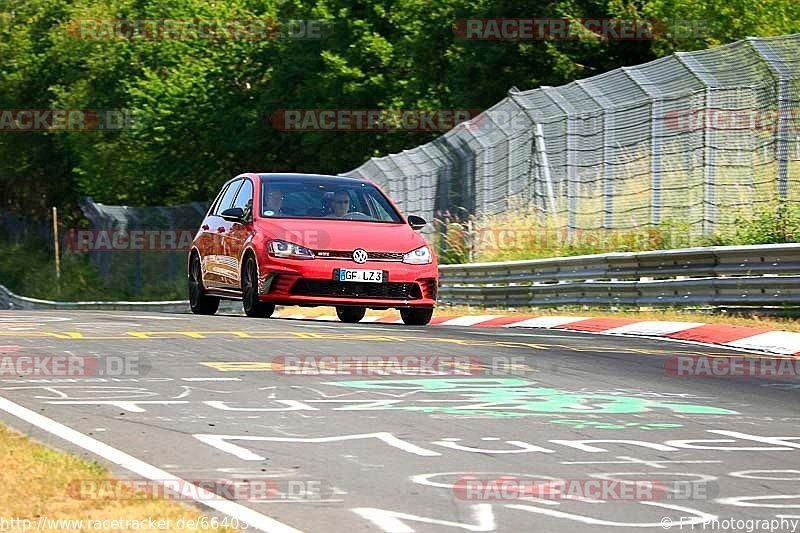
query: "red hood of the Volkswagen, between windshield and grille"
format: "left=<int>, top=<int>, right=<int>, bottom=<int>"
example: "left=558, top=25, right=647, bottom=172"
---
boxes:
left=259, top=219, right=427, bottom=253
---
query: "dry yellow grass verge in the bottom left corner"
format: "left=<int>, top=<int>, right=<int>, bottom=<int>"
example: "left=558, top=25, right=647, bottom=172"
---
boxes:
left=0, top=425, right=235, bottom=533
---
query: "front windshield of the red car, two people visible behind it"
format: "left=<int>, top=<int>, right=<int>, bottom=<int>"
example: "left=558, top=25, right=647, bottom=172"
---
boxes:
left=261, top=179, right=402, bottom=223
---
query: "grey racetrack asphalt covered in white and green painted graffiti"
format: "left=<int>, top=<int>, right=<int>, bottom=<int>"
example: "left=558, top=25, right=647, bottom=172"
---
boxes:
left=0, top=311, right=800, bottom=532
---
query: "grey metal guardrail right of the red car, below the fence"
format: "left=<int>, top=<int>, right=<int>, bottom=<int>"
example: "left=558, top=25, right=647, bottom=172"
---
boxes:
left=439, top=244, right=800, bottom=307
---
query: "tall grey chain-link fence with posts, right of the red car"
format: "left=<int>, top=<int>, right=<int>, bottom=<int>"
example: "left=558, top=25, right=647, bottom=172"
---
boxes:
left=344, top=34, right=800, bottom=241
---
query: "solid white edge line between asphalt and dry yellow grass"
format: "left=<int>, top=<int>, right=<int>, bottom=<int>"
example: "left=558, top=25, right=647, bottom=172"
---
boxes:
left=0, top=397, right=301, bottom=533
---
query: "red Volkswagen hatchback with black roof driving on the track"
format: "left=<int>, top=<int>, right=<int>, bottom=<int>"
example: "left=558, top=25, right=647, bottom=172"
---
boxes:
left=189, top=173, right=439, bottom=325
